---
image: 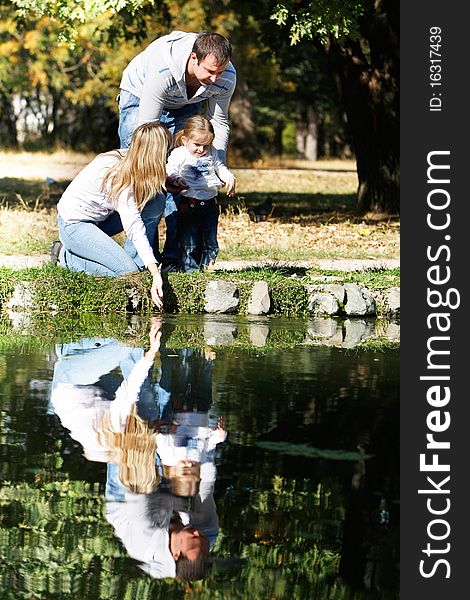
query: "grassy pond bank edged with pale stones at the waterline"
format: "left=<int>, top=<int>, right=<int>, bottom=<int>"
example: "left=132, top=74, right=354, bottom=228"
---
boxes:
left=1, top=257, right=400, bottom=318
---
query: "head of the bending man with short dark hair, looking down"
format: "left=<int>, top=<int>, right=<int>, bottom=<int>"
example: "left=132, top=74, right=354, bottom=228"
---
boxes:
left=188, top=31, right=232, bottom=85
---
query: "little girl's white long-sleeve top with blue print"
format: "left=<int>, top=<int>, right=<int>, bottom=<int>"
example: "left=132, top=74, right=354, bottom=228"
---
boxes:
left=166, top=146, right=235, bottom=200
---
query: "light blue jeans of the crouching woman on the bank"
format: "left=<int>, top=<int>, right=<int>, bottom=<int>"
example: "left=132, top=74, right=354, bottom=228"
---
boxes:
left=58, top=194, right=165, bottom=277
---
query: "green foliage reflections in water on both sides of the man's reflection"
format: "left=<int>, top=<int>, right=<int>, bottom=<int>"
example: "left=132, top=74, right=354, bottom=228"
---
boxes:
left=0, top=472, right=396, bottom=600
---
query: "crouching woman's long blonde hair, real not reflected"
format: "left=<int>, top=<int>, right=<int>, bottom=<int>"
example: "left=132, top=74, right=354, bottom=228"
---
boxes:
left=101, top=122, right=172, bottom=210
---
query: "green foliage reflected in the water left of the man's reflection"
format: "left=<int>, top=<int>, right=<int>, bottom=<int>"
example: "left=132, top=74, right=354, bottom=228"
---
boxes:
left=0, top=473, right=185, bottom=600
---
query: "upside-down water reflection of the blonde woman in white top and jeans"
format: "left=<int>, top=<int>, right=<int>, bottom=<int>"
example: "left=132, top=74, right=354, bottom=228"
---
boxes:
left=51, top=319, right=160, bottom=492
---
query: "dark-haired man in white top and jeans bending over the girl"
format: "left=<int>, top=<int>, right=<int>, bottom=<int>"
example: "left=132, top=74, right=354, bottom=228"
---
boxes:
left=118, top=31, right=236, bottom=264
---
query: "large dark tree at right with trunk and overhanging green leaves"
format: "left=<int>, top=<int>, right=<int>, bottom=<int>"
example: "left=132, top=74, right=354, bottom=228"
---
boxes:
left=273, top=0, right=399, bottom=213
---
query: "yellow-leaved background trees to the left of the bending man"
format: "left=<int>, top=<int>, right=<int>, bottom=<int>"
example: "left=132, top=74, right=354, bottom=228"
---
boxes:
left=0, top=0, right=173, bottom=151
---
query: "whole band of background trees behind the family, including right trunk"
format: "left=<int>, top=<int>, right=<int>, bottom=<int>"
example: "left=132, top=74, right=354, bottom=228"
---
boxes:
left=4, top=0, right=399, bottom=213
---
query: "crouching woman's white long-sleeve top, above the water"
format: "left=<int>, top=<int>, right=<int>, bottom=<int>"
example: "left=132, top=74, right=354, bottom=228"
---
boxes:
left=57, top=150, right=158, bottom=267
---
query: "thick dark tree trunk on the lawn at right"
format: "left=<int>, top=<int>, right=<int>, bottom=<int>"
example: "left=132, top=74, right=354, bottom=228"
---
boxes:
left=327, top=1, right=400, bottom=214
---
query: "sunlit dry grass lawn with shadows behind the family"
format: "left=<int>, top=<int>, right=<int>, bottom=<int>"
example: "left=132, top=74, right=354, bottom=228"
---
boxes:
left=0, top=152, right=400, bottom=261
